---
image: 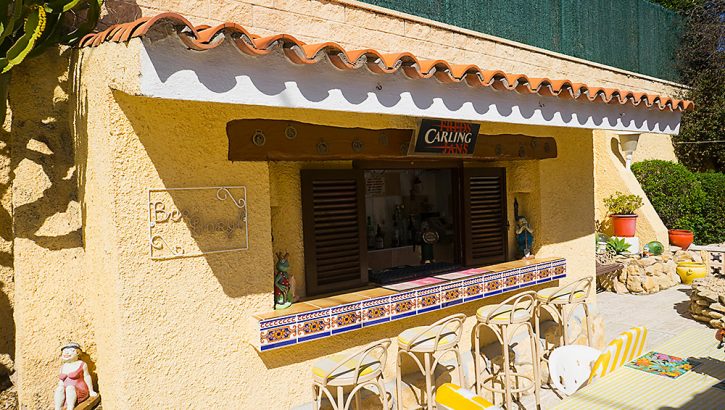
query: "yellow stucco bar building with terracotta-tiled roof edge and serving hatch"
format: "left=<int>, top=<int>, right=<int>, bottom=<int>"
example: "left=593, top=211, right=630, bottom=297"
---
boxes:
left=0, top=0, right=690, bottom=409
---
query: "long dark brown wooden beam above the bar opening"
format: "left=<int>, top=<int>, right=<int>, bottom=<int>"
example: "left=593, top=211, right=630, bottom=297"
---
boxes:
left=227, top=119, right=557, bottom=161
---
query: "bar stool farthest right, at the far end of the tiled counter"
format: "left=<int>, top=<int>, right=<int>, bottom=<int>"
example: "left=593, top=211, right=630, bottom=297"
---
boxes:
left=535, top=277, right=594, bottom=346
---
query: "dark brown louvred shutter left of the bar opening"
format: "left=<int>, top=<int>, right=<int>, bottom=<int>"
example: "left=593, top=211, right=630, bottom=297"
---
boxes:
left=301, top=169, right=368, bottom=296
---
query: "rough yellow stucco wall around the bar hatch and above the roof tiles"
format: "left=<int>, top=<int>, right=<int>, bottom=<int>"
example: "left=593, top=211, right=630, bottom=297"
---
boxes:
left=0, top=0, right=677, bottom=409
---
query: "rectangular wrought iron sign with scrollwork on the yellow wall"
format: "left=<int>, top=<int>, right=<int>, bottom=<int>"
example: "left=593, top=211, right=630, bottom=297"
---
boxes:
left=148, top=186, right=249, bottom=259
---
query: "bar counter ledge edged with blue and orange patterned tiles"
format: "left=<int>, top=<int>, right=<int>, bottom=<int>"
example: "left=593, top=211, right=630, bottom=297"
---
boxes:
left=254, top=258, right=566, bottom=351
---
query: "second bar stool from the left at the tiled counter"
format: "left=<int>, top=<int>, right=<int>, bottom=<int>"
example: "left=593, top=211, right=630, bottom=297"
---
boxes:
left=395, top=313, right=466, bottom=410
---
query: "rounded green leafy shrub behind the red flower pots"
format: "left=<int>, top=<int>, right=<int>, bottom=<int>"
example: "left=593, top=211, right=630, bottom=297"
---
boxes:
left=632, top=160, right=725, bottom=244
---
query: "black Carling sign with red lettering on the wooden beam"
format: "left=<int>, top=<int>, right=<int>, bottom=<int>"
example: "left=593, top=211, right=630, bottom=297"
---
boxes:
left=410, top=118, right=481, bottom=156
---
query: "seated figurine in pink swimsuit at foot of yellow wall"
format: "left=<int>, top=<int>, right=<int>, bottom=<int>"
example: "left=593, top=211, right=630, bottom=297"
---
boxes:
left=55, top=343, right=98, bottom=410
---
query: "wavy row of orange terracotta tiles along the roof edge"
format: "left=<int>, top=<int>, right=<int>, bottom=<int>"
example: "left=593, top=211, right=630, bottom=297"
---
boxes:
left=79, top=13, right=694, bottom=111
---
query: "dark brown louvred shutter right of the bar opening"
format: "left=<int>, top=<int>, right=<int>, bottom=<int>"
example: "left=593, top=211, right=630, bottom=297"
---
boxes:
left=463, top=168, right=508, bottom=265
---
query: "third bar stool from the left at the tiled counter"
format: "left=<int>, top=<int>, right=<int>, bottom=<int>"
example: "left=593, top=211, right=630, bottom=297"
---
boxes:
left=474, top=291, right=541, bottom=409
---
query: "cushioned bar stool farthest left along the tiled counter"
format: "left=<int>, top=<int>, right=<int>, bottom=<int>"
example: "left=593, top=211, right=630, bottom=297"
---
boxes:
left=312, top=340, right=390, bottom=410
